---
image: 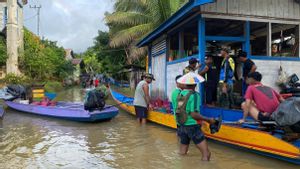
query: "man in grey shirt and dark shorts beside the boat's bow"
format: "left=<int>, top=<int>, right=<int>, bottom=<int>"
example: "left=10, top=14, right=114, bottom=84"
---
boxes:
left=133, top=73, right=155, bottom=124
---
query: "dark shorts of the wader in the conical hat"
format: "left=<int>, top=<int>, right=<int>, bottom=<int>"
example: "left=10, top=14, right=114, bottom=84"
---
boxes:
left=177, top=125, right=205, bottom=145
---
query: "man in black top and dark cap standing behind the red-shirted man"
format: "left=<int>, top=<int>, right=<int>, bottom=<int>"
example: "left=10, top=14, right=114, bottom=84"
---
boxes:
left=238, top=50, right=257, bottom=95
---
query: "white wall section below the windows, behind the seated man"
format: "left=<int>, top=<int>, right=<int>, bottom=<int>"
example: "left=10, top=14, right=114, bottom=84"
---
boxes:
left=253, top=60, right=300, bottom=90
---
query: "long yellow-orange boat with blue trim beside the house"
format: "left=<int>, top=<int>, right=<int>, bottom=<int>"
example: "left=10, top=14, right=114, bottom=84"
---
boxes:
left=111, top=90, right=300, bottom=165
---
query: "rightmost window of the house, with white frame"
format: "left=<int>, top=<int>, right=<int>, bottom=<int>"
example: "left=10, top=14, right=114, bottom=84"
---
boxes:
left=271, top=23, right=299, bottom=57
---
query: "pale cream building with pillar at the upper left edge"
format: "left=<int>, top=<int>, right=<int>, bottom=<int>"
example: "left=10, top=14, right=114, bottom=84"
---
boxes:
left=0, top=0, right=27, bottom=78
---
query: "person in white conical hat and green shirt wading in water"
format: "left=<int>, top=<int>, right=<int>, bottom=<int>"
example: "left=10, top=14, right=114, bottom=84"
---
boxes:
left=172, top=72, right=215, bottom=161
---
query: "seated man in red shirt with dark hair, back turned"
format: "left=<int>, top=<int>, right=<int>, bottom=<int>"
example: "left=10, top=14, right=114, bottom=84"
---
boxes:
left=239, top=72, right=284, bottom=123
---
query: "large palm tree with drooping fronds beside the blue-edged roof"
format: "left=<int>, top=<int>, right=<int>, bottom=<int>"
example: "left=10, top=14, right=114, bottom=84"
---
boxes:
left=105, top=0, right=188, bottom=64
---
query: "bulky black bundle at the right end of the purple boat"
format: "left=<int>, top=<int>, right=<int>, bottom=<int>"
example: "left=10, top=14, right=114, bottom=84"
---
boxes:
left=84, top=90, right=105, bottom=112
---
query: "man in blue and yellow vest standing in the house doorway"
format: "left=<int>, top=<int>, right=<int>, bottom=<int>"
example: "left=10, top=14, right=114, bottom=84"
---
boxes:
left=219, top=48, right=235, bottom=108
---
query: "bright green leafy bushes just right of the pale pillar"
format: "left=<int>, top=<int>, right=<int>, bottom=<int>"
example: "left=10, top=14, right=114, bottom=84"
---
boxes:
left=19, top=29, right=73, bottom=80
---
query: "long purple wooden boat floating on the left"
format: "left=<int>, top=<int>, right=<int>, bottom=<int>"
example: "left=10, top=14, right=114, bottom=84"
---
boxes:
left=5, top=101, right=119, bottom=122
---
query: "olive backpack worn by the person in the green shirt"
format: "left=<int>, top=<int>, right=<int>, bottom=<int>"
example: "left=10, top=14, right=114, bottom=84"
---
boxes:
left=175, top=91, right=195, bottom=125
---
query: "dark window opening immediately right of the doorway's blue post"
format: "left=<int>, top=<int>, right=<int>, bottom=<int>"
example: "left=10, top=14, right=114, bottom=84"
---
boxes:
left=250, top=22, right=268, bottom=56
